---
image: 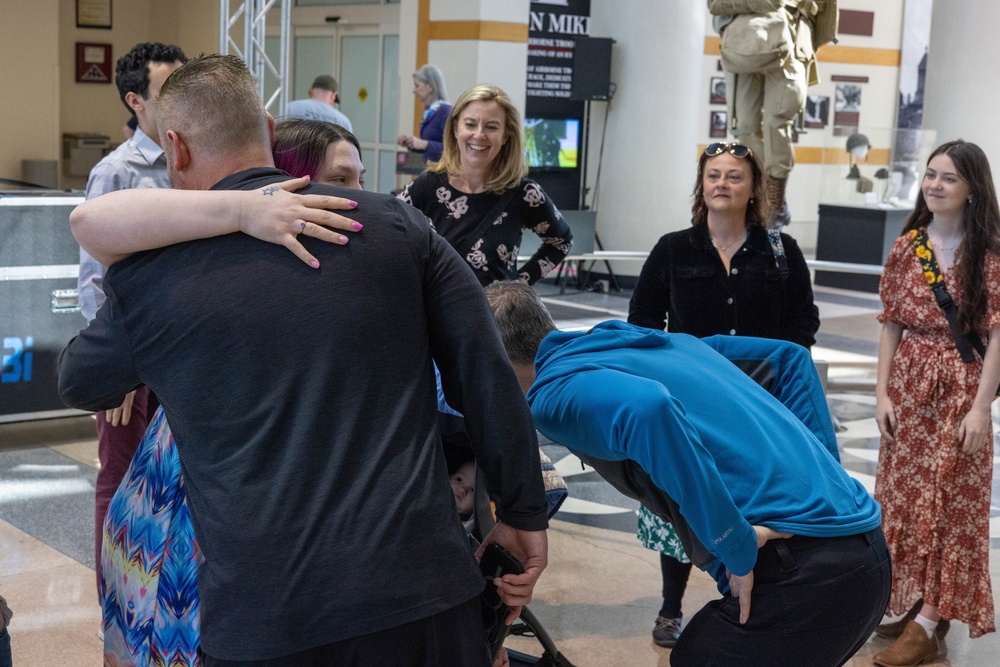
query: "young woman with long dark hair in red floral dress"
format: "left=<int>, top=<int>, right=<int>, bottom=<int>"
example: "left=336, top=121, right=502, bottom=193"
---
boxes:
left=874, top=141, right=1000, bottom=667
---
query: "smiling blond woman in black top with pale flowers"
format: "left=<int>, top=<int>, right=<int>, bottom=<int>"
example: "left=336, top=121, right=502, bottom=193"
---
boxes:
left=399, top=84, right=573, bottom=286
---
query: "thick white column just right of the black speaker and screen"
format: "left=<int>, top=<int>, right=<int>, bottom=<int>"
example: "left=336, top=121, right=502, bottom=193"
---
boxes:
left=587, top=0, right=707, bottom=275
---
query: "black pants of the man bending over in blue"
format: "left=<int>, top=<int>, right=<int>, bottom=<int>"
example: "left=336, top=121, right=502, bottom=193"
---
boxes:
left=670, top=528, right=892, bottom=667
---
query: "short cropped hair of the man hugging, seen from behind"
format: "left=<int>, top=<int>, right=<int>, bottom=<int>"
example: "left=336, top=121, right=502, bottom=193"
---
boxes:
left=156, top=54, right=271, bottom=156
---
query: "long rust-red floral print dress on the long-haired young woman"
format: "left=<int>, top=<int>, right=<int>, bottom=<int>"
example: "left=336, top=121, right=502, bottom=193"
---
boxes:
left=875, top=235, right=1000, bottom=637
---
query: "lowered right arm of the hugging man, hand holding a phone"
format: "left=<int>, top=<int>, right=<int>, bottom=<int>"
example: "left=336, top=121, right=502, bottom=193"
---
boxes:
left=416, top=211, right=548, bottom=622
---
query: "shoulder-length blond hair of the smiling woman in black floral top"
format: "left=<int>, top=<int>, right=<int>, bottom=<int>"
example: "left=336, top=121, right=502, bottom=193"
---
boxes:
left=430, top=84, right=528, bottom=194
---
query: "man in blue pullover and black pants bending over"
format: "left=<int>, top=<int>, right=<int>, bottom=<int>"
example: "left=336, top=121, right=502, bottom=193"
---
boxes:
left=487, top=283, right=890, bottom=667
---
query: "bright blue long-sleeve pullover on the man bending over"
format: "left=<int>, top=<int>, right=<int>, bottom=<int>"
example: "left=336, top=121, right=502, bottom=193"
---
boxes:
left=528, top=321, right=881, bottom=590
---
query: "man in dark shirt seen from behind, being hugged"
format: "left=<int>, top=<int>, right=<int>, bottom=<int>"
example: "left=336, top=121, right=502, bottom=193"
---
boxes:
left=60, top=56, right=547, bottom=667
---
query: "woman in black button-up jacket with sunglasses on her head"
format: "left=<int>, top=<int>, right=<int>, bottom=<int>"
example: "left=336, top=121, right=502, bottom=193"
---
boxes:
left=628, top=143, right=819, bottom=648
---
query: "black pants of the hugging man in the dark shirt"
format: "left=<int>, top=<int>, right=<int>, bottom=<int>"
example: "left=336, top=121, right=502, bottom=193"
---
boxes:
left=203, top=595, right=492, bottom=667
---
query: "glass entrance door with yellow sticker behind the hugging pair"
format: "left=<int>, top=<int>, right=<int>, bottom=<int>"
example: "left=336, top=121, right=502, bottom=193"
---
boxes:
left=289, top=25, right=399, bottom=192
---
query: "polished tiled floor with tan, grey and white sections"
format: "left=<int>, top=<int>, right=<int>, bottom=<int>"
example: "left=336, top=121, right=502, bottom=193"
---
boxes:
left=0, top=286, right=1000, bottom=667
